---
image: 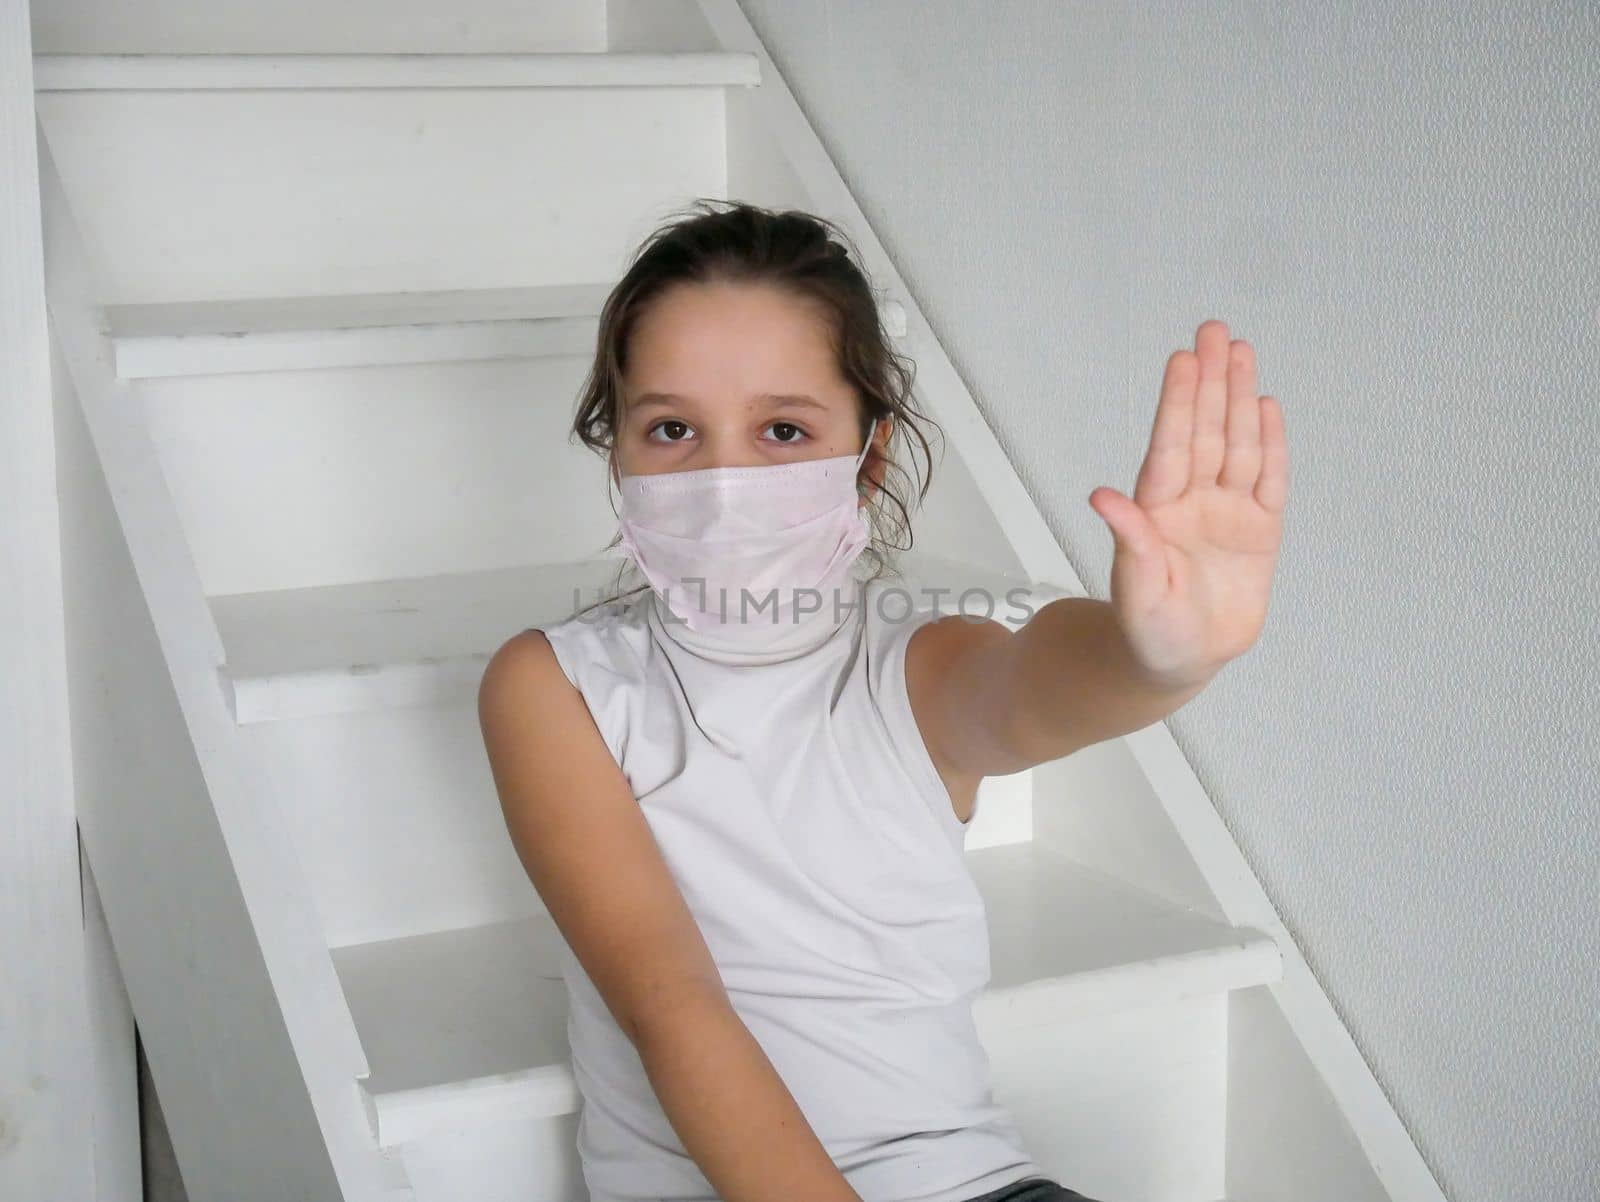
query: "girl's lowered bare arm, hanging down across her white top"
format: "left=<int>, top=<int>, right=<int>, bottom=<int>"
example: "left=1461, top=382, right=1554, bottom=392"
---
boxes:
left=478, top=631, right=861, bottom=1202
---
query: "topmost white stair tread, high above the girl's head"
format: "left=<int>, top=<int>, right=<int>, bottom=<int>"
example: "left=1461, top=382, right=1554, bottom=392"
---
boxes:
left=34, top=51, right=762, bottom=93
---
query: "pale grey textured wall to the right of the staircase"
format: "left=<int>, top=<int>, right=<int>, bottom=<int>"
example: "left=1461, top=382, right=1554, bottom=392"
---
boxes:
left=742, top=0, right=1600, bottom=1202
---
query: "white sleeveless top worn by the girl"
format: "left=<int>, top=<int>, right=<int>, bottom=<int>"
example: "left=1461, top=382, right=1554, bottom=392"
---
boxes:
left=538, top=573, right=1043, bottom=1202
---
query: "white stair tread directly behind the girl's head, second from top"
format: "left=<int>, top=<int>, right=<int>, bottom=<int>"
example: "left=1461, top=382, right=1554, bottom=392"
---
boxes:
left=104, top=283, right=906, bottom=379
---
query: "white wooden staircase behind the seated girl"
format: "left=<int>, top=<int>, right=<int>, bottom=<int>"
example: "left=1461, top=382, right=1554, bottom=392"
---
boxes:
left=35, top=0, right=1442, bottom=1202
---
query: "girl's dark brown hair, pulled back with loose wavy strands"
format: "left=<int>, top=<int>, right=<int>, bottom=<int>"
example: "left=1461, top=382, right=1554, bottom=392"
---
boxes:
left=573, top=197, right=938, bottom=608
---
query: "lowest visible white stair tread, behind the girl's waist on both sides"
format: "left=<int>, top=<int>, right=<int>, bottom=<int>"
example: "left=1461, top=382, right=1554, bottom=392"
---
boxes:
left=333, top=842, right=1282, bottom=1148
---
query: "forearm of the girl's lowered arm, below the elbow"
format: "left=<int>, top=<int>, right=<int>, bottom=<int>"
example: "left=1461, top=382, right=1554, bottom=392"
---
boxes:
left=635, top=997, right=861, bottom=1202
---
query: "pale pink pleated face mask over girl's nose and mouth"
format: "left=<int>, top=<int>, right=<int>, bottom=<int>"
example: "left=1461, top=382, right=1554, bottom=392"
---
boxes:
left=619, top=421, right=878, bottom=631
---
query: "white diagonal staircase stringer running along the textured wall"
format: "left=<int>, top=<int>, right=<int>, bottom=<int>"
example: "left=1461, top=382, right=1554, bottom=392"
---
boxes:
left=696, top=0, right=1445, bottom=1202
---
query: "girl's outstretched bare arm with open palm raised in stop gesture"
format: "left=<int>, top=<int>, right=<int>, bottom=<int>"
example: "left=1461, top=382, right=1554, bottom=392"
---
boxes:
left=906, top=320, right=1288, bottom=776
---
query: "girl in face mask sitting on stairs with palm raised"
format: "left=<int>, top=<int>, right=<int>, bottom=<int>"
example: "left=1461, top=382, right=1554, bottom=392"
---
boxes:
left=478, top=202, right=1283, bottom=1202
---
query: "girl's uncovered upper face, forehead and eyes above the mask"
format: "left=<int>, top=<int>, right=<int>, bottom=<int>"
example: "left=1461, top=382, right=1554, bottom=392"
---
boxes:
left=614, top=283, right=886, bottom=475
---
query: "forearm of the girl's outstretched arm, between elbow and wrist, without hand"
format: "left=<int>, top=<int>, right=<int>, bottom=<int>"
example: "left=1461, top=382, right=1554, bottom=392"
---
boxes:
left=997, top=597, right=1210, bottom=763
